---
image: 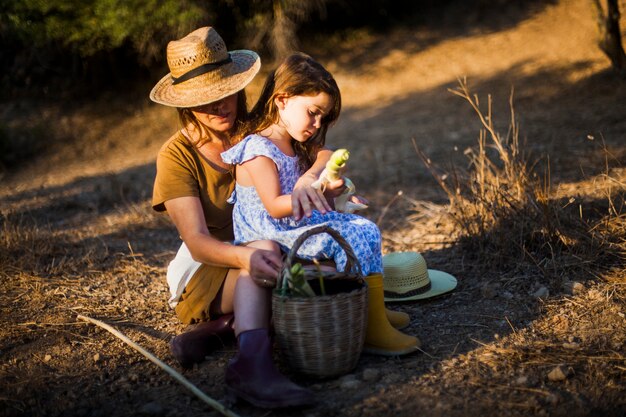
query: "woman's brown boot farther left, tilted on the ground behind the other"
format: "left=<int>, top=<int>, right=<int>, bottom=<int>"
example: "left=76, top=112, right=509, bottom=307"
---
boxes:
left=170, top=314, right=235, bottom=369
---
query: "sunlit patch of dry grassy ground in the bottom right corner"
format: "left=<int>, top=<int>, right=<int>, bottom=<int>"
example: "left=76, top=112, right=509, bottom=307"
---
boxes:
left=430, top=274, right=626, bottom=415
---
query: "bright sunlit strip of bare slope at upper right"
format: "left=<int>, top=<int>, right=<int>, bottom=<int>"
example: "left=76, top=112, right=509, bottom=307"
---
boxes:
left=331, top=2, right=609, bottom=109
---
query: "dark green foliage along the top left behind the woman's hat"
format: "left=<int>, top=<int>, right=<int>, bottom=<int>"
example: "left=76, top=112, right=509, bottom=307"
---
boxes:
left=0, top=0, right=424, bottom=99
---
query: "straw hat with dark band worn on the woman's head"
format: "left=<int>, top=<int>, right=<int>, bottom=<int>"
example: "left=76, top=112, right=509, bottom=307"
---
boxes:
left=150, top=27, right=261, bottom=107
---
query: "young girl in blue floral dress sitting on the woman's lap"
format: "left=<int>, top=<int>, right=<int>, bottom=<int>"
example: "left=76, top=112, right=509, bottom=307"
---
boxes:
left=221, top=53, right=419, bottom=355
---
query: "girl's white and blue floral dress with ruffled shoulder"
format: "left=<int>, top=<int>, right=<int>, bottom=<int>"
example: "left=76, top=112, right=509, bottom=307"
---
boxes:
left=221, top=135, right=383, bottom=276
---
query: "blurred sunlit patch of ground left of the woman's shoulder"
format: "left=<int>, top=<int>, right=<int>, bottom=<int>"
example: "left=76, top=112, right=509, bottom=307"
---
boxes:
left=0, top=101, right=177, bottom=193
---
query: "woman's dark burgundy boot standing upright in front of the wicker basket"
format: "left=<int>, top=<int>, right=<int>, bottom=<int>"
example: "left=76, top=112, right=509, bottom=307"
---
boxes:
left=224, top=329, right=315, bottom=408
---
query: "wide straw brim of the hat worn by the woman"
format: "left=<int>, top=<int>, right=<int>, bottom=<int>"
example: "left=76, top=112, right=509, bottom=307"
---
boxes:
left=150, top=50, right=261, bottom=108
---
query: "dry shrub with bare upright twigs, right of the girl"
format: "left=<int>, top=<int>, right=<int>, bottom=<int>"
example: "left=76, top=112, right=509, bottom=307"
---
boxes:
left=416, top=80, right=626, bottom=284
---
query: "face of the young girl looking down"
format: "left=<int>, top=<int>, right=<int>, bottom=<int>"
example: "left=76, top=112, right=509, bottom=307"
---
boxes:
left=276, top=93, right=334, bottom=142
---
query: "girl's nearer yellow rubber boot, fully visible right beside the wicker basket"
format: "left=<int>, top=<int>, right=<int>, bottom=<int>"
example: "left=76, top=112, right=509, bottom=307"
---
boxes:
left=363, top=274, right=421, bottom=356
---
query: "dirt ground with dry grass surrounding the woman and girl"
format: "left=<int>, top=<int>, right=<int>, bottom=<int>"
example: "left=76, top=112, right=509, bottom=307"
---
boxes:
left=0, top=0, right=626, bottom=417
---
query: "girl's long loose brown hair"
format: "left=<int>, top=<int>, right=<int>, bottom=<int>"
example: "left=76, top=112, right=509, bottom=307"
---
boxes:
left=243, top=52, right=341, bottom=172
